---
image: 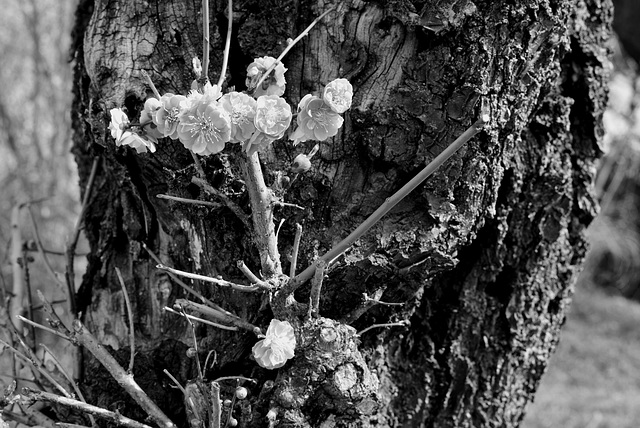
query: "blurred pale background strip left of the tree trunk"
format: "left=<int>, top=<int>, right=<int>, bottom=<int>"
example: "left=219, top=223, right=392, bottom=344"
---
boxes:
left=0, top=0, right=84, bottom=396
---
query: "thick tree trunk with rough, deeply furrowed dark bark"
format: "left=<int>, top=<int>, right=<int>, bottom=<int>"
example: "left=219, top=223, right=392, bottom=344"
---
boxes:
left=73, top=0, right=612, bottom=427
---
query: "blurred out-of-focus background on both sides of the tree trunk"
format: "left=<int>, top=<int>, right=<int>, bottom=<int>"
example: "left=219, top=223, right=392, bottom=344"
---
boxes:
left=0, top=0, right=640, bottom=428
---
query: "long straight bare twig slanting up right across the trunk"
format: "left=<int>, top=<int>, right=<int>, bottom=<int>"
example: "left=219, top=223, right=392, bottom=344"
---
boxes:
left=283, top=115, right=489, bottom=293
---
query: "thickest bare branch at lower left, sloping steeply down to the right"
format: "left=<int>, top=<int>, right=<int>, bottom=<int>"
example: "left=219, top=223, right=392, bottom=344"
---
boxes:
left=73, top=320, right=175, bottom=428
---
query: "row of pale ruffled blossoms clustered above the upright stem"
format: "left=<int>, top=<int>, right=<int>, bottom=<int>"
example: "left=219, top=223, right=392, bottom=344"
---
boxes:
left=109, top=56, right=353, bottom=156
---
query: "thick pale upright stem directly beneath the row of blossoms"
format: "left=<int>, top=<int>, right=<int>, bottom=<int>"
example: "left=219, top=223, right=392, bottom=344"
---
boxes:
left=242, top=153, right=282, bottom=279
